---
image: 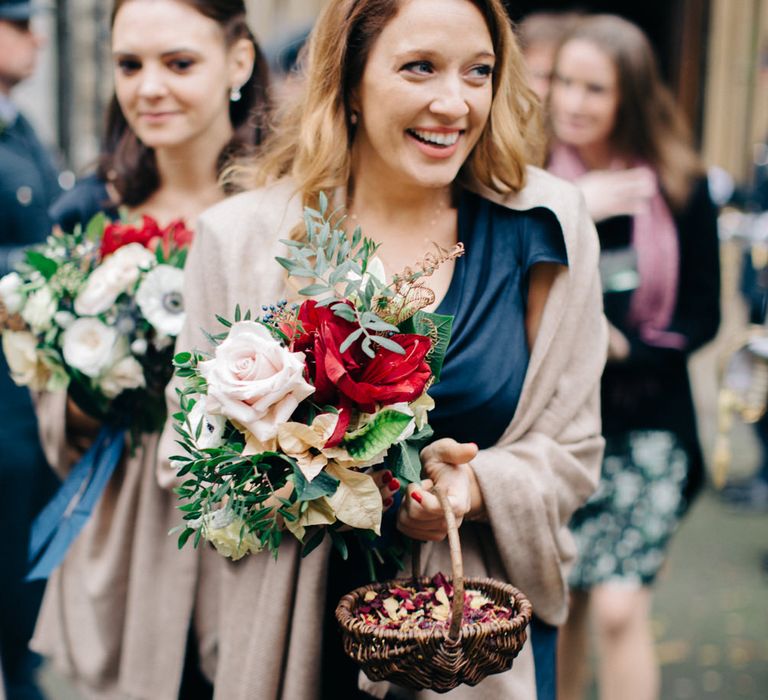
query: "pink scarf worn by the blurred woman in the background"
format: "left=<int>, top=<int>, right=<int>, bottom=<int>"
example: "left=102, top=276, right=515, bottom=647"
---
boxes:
left=548, top=144, right=686, bottom=350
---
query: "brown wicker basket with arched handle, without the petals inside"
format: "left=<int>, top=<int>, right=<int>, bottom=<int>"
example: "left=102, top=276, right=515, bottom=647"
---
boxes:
left=336, top=489, right=533, bottom=693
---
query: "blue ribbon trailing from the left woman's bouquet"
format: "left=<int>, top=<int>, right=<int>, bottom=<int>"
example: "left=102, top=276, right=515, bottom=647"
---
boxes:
left=26, top=426, right=125, bottom=581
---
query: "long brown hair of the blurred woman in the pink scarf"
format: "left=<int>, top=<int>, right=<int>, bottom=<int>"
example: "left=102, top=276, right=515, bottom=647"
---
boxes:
left=561, top=15, right=704, bottom=210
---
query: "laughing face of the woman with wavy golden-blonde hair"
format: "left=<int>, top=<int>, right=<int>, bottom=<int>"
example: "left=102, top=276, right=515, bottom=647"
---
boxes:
left=353, top=0, right=494, bottom=187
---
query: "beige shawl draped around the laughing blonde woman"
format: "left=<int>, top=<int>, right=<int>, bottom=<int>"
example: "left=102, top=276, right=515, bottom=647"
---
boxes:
left=158, top=168, right=606, bottom=700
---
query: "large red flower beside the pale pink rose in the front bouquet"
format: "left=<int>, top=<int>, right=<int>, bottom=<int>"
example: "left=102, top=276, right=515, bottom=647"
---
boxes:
left=295, top=300, right=432, bottom=446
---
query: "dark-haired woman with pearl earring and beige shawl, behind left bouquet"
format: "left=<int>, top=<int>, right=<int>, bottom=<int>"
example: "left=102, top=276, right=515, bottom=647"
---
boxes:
left=33, top=0, right=267, bottom=700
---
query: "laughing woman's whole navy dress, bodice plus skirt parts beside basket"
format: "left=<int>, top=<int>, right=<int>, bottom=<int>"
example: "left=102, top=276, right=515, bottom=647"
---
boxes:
left=323, top=192, right=567, bottom=700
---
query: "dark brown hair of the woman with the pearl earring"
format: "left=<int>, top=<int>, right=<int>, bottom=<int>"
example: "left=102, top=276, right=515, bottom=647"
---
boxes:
left=98, top=0, right=269, bottom=206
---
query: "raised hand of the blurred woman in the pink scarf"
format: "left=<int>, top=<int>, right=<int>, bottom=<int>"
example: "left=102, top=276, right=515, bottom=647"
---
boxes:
left=576, top=168, right=656, bottom=222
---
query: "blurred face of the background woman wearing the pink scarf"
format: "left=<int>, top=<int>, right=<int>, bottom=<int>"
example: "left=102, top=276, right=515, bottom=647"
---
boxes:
left=550, top=39, right=619, bottom=154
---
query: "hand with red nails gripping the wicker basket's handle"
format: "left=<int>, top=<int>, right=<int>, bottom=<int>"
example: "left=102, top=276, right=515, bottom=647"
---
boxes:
left=397, top=438, right=484, bottom=542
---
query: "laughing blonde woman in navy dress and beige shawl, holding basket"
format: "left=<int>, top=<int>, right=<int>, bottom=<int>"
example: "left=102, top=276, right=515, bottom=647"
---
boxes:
left=159, top=0, right=605, bottom=700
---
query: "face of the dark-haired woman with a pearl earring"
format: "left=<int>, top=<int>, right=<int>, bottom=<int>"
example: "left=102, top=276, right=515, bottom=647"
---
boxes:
left=112, top=0, right=242, bottom=148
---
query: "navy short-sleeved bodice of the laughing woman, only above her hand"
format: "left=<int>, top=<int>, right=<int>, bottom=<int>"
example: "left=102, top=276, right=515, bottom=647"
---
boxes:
left=429, top=192, right=568, bottom=449
